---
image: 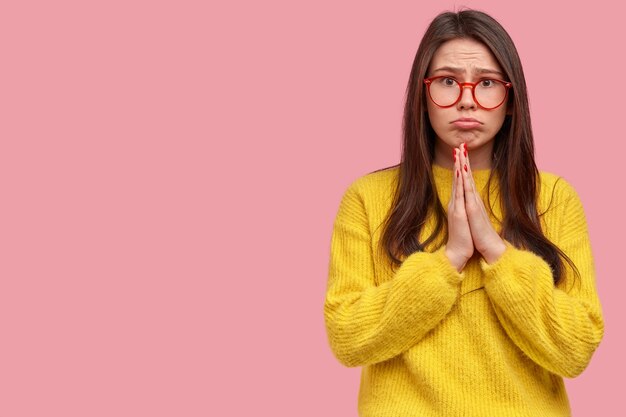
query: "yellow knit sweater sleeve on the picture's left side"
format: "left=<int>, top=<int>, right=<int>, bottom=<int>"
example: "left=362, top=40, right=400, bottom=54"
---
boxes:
left=324, top=179, right=464, bottom=367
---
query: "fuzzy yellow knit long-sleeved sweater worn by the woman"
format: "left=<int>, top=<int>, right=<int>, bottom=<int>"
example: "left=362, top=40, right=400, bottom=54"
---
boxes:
left=324, top=165, right=604, bottom=417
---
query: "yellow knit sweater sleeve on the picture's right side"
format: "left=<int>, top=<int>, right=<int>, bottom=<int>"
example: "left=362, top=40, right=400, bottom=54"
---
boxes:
left=481, top=179, right=604, bottom=378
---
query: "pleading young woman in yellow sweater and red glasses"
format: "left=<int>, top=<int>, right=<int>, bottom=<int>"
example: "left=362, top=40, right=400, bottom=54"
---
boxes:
left=324, top=10, right=604, bottom=417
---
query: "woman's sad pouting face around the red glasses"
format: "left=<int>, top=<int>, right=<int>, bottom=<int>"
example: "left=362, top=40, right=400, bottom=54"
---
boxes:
left=426, top=38, right=510, bottom=165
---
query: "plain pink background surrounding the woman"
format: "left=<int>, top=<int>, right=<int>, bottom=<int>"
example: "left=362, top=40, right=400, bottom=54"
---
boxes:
left=0, top=0, right=626, bottom=417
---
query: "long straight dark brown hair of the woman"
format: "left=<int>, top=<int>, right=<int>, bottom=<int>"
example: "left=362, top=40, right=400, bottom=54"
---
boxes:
left=378, top=9, right=579, bottom=285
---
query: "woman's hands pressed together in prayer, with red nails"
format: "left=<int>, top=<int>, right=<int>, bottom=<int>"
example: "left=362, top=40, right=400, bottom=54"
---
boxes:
left=445, top=143, right=506, bottom=272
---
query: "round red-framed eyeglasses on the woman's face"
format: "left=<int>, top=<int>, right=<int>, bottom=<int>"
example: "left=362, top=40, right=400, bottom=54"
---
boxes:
left=424, top=75, right=513, bottom=110
